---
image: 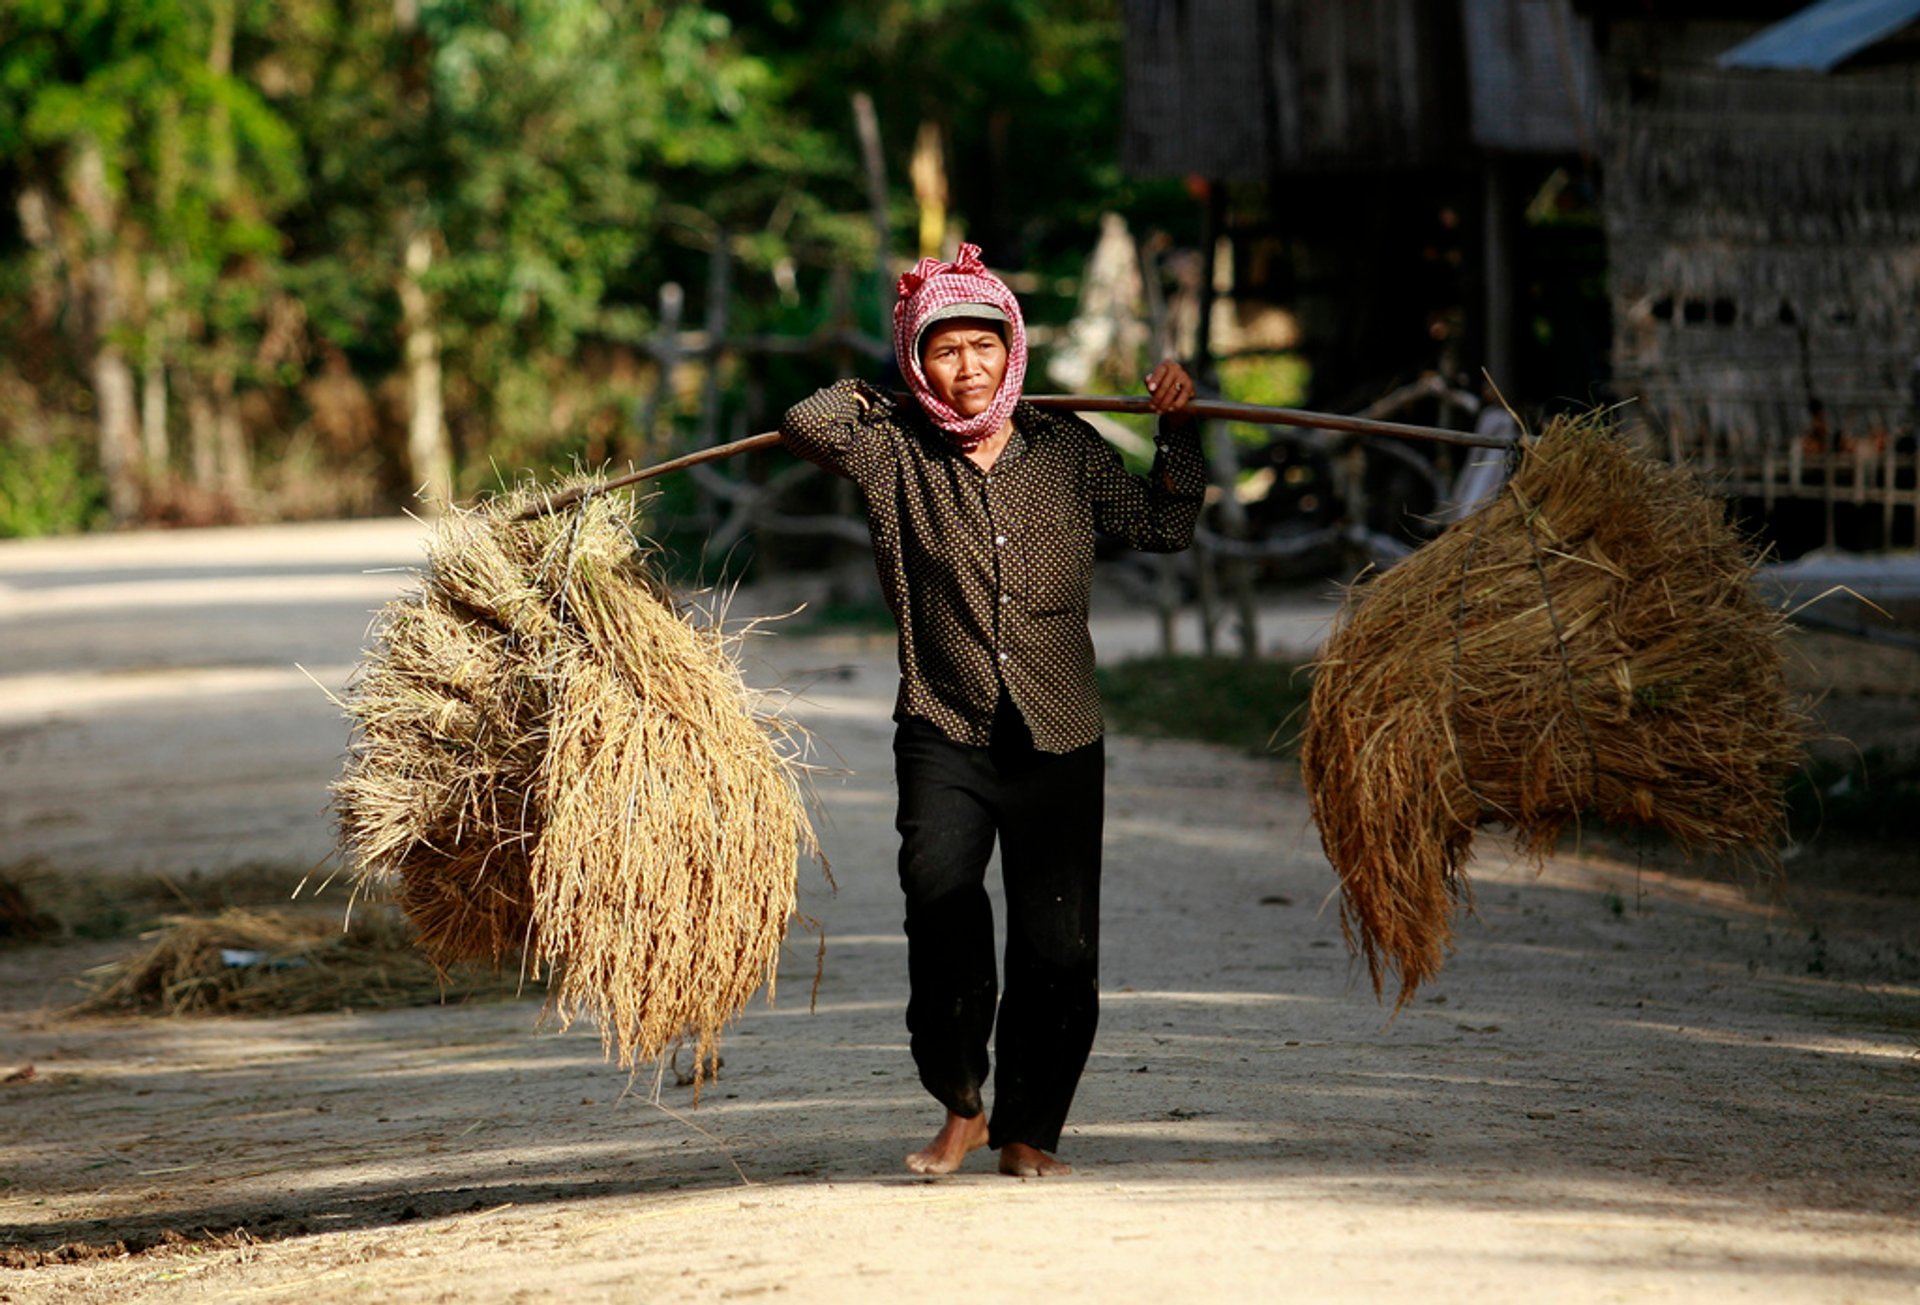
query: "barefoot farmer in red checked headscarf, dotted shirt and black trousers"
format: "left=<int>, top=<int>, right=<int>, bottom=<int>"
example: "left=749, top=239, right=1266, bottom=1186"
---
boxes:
left=781, top=246, right=1206, bottom=1176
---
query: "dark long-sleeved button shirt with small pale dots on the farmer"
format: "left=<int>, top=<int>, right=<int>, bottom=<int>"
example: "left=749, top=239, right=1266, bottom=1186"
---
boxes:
left=781, top=380, right=1206, bottom=752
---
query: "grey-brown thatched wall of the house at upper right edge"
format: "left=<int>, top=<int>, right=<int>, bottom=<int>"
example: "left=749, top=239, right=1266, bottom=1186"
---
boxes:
left=1603, top=21, right=1920, bottom=530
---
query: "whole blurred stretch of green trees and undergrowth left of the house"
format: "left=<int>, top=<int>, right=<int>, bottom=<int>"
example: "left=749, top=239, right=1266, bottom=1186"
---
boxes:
left=0, top=0, right=1194, bottom=535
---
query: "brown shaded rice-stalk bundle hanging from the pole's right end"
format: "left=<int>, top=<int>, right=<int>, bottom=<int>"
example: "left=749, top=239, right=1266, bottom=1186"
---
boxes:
left=1300, top=415, right=1807, bottom=1009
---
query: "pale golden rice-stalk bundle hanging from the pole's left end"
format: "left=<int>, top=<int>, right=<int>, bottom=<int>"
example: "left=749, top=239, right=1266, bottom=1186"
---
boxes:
left=334, top=475, right=814, bottom=1067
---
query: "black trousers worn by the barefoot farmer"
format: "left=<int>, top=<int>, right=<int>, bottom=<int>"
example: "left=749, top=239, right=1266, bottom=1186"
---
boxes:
left=893, top=693, right=1106, bottom=1151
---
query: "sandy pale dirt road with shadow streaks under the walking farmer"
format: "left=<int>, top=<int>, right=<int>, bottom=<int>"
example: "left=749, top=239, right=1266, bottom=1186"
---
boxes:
left=0, top=522, right=1920, bottom=1301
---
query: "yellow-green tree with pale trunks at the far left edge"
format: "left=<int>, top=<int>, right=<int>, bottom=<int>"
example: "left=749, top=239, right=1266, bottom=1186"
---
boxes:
left=0, top=0, right=300, bottom=520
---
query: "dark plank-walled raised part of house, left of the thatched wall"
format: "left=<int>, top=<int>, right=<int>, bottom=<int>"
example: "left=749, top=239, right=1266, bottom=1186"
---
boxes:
left=1123, top=0, right=1603, bottom=414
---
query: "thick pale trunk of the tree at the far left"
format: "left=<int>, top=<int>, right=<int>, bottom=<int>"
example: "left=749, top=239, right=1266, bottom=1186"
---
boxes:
left=67, top=140, right=140, bottom=522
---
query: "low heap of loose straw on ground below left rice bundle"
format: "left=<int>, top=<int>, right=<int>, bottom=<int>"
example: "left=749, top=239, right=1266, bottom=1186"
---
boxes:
left=77, top=908, right=513, bottom=1015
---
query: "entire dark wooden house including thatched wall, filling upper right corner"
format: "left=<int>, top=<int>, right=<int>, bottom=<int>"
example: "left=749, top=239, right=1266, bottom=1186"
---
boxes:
left=1123, top=0, right=1920, bottom=553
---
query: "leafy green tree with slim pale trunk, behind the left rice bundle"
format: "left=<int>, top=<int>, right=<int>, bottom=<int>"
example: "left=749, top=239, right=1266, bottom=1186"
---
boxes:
left=266, top=0, right=839, bottom=498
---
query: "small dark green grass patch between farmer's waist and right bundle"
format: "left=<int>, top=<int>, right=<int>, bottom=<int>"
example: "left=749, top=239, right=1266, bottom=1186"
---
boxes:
left=1098, top=656, right=1313, bottom=756
